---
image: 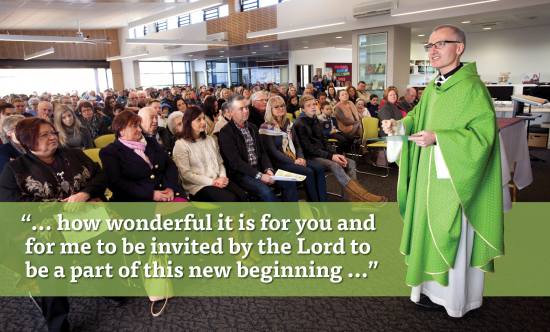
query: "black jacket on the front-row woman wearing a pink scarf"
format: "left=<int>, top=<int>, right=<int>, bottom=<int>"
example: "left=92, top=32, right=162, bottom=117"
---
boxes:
left=99, top=137, right=187, bottom=202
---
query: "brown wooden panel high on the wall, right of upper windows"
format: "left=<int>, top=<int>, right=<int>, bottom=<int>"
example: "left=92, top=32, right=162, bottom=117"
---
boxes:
left=206, top=6, right=277, bottom=49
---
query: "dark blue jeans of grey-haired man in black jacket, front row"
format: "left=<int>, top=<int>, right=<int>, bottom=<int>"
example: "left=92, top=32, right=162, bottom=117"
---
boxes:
left=237, top=175, right=298, bottom=202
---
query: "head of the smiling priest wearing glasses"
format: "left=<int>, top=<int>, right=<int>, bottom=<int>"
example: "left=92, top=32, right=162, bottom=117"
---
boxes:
left=428, top=28, right=464, bottom=75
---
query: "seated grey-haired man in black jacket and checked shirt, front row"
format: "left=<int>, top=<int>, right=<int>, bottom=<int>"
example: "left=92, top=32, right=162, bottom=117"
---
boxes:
left=218, top=94, right=298, bottom=202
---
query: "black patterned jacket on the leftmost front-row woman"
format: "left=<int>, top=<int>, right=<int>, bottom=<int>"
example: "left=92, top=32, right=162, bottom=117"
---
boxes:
left=0, top=148, right=107, bottom=202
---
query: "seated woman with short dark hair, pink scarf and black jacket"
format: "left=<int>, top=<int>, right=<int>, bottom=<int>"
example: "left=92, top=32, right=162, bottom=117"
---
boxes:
left=99, top=111, right=187, bottom=202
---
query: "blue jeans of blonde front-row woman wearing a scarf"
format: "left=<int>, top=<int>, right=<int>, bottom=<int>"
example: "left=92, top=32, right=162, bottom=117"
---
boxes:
left=280, top=159, right=327, bottom=202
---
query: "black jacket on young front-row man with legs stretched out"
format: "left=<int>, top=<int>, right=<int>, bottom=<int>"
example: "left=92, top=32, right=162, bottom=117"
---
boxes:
left=294, top=112, right=336, bottom=160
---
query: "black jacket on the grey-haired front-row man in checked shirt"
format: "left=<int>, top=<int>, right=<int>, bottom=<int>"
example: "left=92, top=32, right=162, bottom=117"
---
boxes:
left=218, top=120, right=273, bottom=182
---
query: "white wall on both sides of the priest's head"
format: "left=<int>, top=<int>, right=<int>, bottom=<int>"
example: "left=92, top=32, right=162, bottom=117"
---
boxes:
left=411, top=25, right=550, bottom=84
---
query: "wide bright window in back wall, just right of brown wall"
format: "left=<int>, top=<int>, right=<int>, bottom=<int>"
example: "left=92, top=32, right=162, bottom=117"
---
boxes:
left=139, top=61, right=191, bottom=87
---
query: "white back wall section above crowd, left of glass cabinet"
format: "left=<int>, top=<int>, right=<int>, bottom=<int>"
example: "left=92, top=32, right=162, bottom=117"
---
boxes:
left=289, top=47, right=355, bottom=86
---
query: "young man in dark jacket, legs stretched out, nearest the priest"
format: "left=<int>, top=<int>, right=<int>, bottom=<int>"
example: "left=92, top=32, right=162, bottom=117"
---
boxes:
left=294, top=95, right=388, bottom=202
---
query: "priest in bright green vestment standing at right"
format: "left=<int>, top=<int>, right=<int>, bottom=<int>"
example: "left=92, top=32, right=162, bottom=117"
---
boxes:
left=382, top=25, right=504, bottom=317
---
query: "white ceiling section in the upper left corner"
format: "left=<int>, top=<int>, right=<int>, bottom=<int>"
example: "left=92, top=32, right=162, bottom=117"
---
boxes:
left=0, top=2, right=183, bottom=30
